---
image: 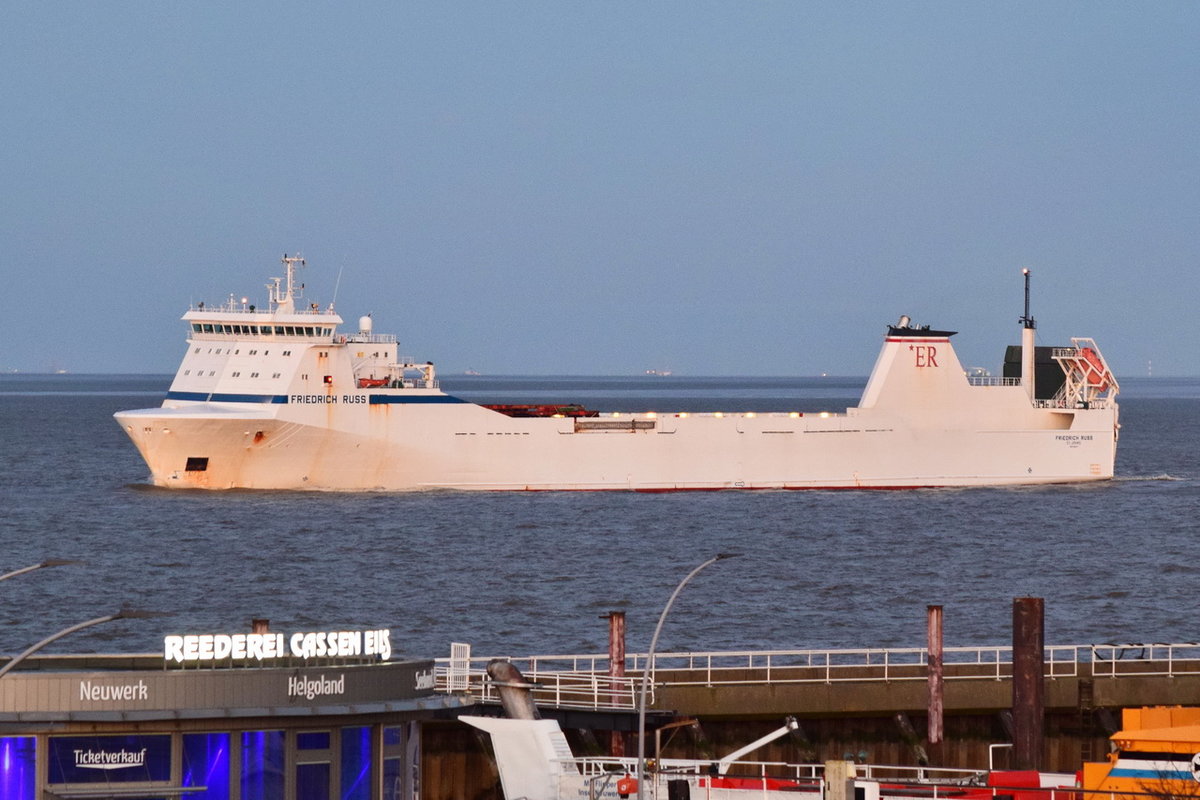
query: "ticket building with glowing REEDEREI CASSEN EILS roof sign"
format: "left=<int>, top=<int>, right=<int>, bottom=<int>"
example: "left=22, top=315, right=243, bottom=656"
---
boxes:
left=0, top=631, right=457, bottom=800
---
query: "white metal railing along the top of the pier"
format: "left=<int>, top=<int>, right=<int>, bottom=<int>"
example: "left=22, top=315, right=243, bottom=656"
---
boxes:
left=436, top=643, right=1200, bottom=709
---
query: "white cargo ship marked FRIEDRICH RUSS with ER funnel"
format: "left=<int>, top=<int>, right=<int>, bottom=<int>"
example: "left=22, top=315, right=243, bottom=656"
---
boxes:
left=115, top=257, right=1118, bottom=492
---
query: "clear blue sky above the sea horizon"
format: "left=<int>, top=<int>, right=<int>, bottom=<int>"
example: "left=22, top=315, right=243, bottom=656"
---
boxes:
left=0, top=0, right=1200, bottom=375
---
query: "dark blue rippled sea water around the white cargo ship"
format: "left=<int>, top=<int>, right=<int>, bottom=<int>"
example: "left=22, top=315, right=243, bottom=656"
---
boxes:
left=0, top=375, right=1200, bottom=657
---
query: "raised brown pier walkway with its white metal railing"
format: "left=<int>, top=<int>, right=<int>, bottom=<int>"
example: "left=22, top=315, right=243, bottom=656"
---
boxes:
left=437, top=643, right=1200, bottom=717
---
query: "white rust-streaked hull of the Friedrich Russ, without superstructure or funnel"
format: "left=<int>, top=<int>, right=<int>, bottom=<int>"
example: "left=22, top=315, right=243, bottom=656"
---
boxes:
left=118, top=390, right=1116, bottom=492
